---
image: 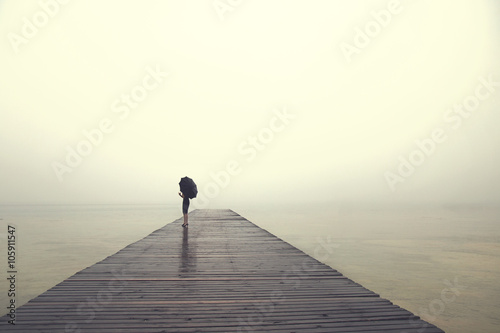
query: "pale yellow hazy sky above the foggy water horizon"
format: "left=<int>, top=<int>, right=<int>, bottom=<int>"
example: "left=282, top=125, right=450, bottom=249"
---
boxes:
left=0, top=0, right=500, bottom=207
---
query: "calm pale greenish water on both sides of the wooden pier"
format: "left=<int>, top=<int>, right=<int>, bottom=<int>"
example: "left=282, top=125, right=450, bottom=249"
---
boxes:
left=0, top=204, right=500, bottom=333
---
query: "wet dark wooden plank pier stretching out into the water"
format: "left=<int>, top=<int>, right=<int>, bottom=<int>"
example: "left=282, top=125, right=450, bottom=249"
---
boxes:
left=0, top=210, right=443, bottom=333
